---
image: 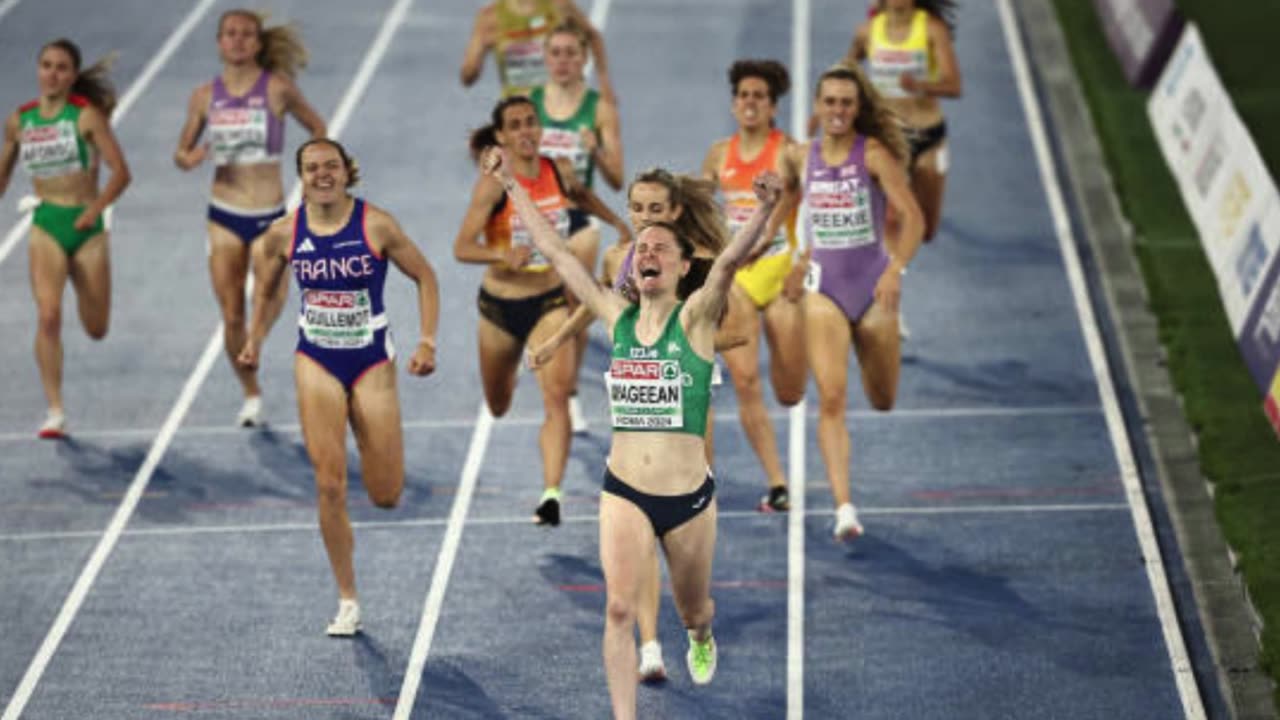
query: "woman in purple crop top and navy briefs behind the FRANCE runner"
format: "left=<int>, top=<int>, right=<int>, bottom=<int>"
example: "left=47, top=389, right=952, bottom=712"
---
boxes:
left=173, top=10, right=325, bottom=425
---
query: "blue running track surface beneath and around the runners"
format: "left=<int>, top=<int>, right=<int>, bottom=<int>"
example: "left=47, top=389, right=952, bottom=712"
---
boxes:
left=0, top=0, right=1213, bottom=719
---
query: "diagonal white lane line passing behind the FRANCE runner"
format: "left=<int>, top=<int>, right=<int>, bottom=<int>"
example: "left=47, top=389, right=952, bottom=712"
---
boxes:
left=0, top=0, right=411, bottom=720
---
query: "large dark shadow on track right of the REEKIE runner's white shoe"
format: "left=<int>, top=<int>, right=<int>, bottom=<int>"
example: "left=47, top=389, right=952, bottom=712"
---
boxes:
left=806, top=528, right=1151, bottom=678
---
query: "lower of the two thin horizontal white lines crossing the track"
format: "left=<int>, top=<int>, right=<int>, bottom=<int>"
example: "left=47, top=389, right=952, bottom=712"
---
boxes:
left=0, top=502, right=1129, bottom=540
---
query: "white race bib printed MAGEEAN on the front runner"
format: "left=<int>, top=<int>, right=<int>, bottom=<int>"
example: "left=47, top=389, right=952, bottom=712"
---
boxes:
left=605, top=357, right=685, bottom=430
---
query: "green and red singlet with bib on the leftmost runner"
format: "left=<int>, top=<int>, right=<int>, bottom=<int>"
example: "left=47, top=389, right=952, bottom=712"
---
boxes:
left=18, top=95, right=90, bottom=178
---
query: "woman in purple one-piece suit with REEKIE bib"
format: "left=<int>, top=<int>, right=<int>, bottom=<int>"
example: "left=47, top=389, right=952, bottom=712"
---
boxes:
left=788, top=64, right=924, bottom=539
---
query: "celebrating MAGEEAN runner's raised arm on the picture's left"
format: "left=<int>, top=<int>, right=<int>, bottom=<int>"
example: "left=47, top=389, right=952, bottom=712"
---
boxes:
left=480, top=147, right=626, bottom=328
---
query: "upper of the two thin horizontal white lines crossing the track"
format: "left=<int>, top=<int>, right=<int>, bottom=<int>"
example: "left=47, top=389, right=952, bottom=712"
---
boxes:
left=0, top=405, right=1102, bottom=443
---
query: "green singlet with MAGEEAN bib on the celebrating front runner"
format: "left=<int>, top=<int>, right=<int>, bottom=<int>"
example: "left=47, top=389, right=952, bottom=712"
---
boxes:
left=605, top=302, right=712, bottom=437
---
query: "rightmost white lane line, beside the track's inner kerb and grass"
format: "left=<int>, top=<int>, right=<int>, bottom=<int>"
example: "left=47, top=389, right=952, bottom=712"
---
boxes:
left=997, top=0, right=1204, bottom=720
